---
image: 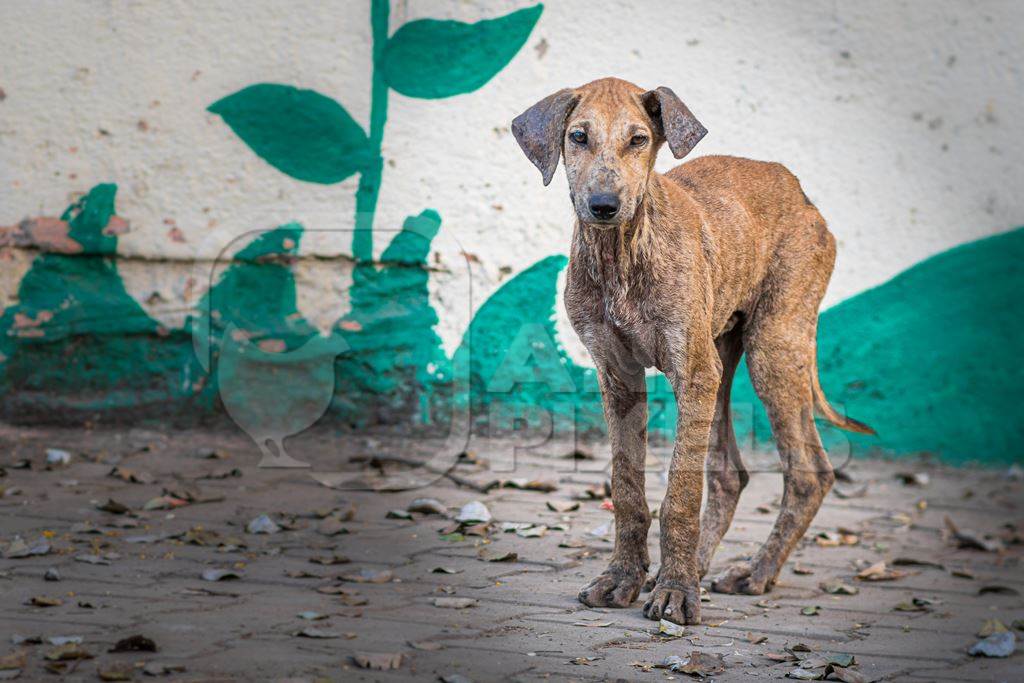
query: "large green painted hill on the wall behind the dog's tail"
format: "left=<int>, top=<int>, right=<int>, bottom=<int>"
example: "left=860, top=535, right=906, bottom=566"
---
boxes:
left=733, top=227, right=1024, bottom=463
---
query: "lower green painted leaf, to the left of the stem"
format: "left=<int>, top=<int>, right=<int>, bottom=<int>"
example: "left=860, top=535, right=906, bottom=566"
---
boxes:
left=209, top=83, right=372, bottom=184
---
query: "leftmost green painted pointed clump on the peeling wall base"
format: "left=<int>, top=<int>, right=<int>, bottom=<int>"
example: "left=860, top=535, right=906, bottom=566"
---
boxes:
left=0, top=184, right=186, bottom=422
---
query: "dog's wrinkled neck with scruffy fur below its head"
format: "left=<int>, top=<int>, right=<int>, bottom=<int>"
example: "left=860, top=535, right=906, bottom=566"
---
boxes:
left=573, top=171, right=665, bottom=289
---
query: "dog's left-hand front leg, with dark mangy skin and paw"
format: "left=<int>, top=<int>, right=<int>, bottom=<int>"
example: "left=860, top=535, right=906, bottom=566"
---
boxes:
left=580, top=361, right=650, bottom=607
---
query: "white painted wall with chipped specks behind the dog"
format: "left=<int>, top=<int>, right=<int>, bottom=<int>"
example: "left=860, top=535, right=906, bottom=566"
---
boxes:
left=0, top=0, right=1024, bottom=360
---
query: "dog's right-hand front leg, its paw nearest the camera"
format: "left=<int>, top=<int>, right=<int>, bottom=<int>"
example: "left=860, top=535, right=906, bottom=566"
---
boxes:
left=643, top=335, right=722, bottom=624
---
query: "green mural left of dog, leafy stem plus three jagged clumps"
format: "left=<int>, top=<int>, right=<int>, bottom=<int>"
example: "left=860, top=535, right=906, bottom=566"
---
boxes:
left=0, top=0, right=543, bottom=444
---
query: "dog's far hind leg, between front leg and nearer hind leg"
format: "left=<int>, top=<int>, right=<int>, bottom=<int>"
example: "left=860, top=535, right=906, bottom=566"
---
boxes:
left=697, top=323, right=750, bottom=577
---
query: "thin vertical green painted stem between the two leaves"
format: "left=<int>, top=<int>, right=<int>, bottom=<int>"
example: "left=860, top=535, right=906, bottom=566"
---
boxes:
left=352, top=0, right=390, bottom=261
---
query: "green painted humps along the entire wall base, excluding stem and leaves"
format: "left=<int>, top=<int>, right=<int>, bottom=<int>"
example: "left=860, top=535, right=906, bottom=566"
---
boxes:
left=0, top=189, right=1024, bottom=462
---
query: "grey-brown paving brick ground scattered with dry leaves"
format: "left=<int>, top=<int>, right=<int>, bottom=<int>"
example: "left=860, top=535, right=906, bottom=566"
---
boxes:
left=0, top=426, right=1024, bottom=681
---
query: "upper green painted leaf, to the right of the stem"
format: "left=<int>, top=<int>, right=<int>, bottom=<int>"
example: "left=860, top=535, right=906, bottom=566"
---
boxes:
left=378, top=4, right=544, bottom=99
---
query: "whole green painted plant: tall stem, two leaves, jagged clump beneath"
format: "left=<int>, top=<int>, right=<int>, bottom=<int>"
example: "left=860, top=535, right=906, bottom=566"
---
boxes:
left=209, top=0, right=543, bottom=426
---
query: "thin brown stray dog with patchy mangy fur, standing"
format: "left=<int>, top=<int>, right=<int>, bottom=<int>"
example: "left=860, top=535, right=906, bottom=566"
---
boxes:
left=512, top=78, right=873, bottom=624
